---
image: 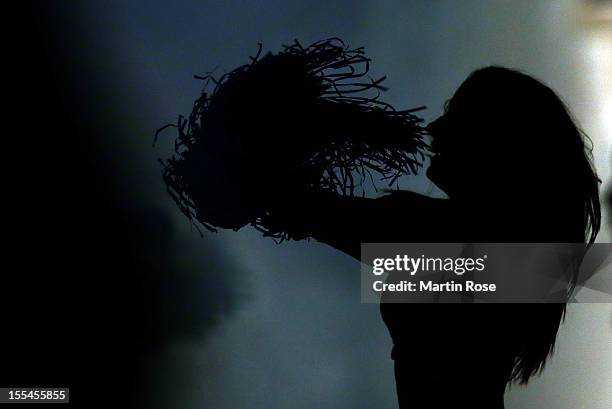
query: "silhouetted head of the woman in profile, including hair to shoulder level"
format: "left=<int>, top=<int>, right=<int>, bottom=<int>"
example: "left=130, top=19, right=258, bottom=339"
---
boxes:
left=427, top=67, right=600, bottom=241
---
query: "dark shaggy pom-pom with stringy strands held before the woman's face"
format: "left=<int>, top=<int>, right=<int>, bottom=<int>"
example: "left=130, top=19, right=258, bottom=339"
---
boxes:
left=156, top=38, right=426, bottom=239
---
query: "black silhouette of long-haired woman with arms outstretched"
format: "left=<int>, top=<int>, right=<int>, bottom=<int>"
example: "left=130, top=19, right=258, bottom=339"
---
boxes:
left=159, top=40, right=600, bottom=409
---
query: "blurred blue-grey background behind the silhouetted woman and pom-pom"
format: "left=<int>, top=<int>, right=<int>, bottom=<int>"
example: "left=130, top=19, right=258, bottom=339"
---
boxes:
left=11, top=0, right=612, bottom=409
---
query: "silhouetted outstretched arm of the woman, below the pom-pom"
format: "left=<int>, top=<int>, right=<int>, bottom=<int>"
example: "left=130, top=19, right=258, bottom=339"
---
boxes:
left=269, top=191, right=448, bottom=259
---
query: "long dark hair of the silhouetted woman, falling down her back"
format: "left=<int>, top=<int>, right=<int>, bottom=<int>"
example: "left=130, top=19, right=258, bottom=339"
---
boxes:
left=447, top=66, right=601, bottom=383
